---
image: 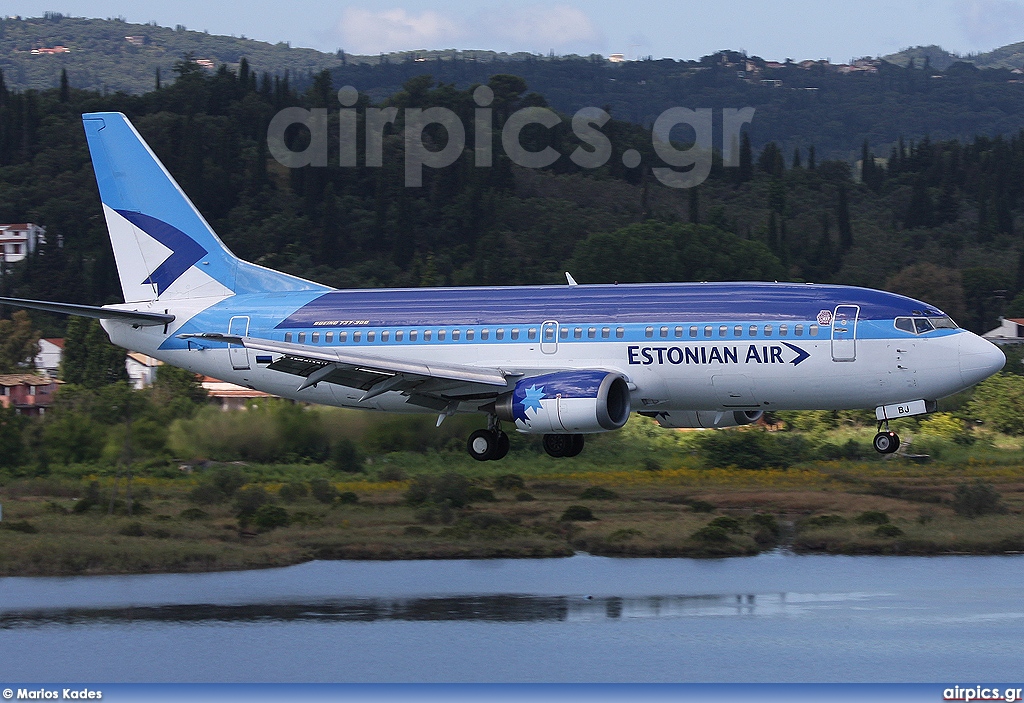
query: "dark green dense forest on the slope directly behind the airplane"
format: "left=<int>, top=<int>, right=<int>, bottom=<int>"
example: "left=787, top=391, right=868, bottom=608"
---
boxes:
left=0, top=59, right=1024, bottom=334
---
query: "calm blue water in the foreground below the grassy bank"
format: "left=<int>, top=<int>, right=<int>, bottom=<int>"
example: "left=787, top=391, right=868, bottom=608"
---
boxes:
left=0, top=554, right=1024, bottom=682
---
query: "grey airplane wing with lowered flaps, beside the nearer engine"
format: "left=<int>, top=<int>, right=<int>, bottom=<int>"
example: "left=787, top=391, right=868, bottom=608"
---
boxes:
left=178, top=333, right=519, bottom=408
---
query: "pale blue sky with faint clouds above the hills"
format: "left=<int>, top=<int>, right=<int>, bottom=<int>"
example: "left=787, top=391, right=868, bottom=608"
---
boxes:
left=8, top=0, right=1024, bottom=62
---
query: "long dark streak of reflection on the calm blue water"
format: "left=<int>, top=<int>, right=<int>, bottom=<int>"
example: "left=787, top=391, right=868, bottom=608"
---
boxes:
left=0, top=594, right=868, bottom=629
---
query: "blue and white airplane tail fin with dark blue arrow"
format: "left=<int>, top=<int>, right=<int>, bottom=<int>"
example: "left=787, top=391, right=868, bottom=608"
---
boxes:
left=82, top=113, right=329, bottom=303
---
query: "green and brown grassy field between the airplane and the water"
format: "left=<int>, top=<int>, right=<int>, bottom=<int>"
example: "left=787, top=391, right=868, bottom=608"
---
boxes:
left=0, top=449, right=1024, bottom=575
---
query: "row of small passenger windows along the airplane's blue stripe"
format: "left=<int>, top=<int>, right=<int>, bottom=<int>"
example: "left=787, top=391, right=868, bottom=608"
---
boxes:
left=285, top=324, right=818, bottom=344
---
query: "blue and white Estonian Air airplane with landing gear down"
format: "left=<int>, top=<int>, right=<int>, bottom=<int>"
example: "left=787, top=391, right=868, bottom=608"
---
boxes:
left=0, top=113, right=1006, bottom=462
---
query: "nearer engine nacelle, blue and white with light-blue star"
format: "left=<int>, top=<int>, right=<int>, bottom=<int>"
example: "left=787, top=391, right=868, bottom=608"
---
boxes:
left=495, top=370, right=630, bottom=434
